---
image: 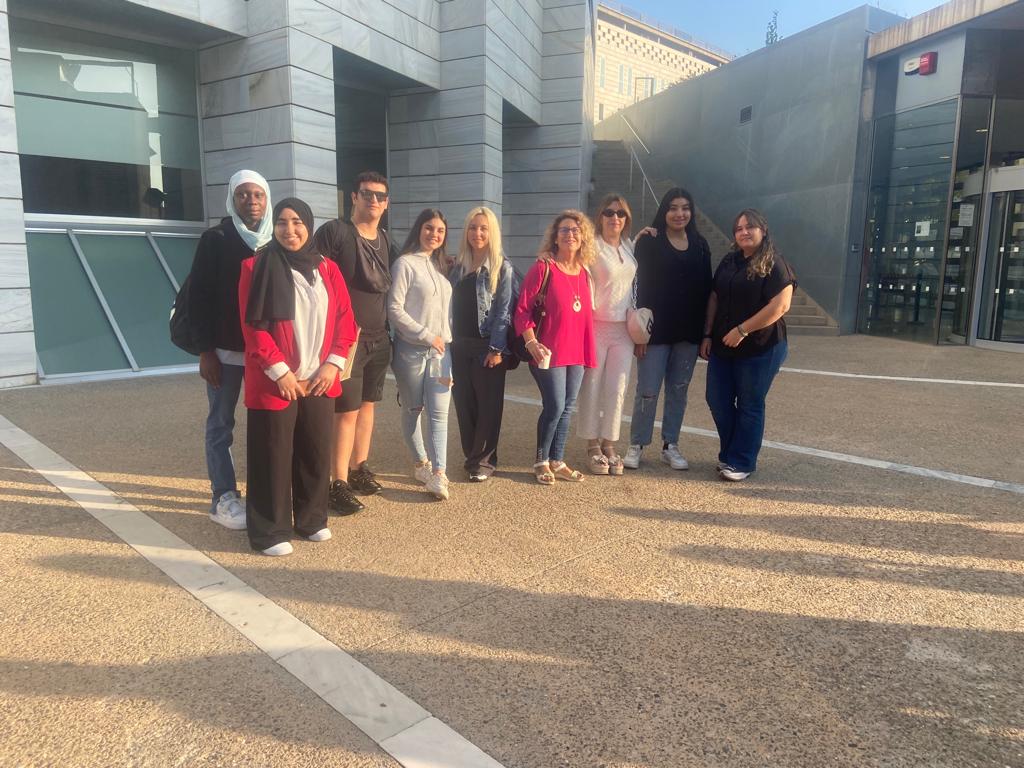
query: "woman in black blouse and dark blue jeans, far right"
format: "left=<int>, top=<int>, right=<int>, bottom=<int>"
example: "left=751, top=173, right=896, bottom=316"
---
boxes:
left=700, top=208, right=797, bottom=482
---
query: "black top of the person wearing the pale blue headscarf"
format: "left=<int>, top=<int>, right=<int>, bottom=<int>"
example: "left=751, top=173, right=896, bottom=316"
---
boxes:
left=188, top=214, right=253, bottom=352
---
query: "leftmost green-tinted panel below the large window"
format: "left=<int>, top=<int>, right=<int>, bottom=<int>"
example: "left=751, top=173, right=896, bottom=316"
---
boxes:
left=26, top=232, right=130, bottom=376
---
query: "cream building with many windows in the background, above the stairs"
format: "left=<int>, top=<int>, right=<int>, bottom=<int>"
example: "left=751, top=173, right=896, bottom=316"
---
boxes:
left=594, top=2, right=732, bottom=122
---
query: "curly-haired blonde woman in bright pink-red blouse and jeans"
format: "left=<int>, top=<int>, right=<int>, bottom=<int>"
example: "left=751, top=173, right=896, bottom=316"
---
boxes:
left=515, top=210, right=597, bottom=485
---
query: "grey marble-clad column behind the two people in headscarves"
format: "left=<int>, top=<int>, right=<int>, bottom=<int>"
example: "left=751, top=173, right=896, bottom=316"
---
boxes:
left=200, top=0, right=338, bottom=224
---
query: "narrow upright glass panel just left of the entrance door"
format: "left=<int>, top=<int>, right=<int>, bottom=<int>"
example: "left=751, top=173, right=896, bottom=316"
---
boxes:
left=939, top=96, right=992, bottom=344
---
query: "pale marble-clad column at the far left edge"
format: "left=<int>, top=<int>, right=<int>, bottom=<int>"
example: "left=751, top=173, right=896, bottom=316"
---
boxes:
left=0, top=0, right=37, bottom=387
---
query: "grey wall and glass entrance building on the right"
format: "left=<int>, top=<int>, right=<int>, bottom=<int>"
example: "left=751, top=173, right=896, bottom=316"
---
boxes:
left=597, top=0, right=1024, bottom=351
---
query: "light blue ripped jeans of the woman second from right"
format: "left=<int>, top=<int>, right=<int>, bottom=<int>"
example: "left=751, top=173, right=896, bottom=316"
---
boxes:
left=630, top=341, right=698, bottom=445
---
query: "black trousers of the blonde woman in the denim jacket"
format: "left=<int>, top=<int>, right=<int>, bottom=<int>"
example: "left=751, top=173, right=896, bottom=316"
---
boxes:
left=452, top=338, right=507, bottom=471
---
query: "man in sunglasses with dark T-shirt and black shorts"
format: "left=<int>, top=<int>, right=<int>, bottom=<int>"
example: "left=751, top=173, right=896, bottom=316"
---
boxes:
left=314, top=171, right=397, bottom=515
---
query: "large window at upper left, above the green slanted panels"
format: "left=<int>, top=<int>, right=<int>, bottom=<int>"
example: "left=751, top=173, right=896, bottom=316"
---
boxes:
left=10, top=18, right=203, bottom=220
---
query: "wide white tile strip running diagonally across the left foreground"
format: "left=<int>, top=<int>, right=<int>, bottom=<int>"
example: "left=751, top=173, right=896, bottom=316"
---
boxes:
left=0, top=416, right=503, bottom=768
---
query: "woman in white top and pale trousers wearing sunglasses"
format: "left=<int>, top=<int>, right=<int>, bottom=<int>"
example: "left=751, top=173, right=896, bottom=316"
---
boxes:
left=578, top=193, right=637, bottom=475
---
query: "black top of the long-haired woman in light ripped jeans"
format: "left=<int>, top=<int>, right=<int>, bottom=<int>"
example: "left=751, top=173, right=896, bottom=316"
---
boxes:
left=634, top=232, right=711, bottom=344
